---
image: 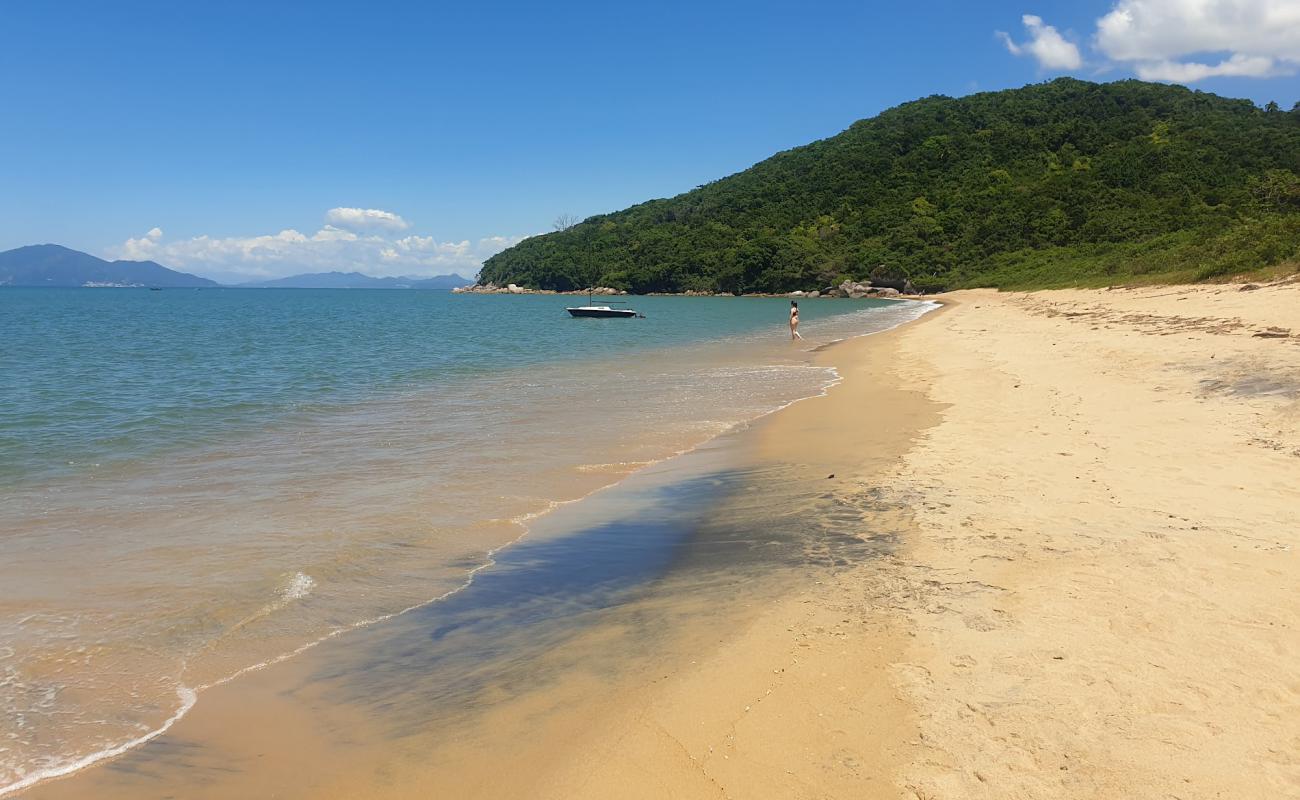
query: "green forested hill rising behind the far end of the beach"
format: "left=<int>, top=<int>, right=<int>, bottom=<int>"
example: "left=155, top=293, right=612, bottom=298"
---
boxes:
left=480, top=78, right=1300, bottom=293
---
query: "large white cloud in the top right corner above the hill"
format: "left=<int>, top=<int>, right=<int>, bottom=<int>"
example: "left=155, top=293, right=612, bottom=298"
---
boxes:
left=1096, top=0, right=1300, bottom=83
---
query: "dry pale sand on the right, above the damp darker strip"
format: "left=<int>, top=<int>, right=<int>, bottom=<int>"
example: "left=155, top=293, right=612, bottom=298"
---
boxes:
left=896, top=284, right=1300, bottom=799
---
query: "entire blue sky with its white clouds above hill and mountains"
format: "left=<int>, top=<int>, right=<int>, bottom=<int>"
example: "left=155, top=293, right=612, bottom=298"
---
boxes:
left=0, top=0, right=1300, bottom=282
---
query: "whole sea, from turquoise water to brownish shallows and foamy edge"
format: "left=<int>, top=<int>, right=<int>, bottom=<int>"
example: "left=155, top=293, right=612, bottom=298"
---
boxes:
left=0, top=289, right=933, bottom=795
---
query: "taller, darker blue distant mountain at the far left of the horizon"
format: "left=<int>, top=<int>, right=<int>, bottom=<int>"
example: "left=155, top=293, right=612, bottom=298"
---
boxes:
left=0, top=245, right=217, bottom=287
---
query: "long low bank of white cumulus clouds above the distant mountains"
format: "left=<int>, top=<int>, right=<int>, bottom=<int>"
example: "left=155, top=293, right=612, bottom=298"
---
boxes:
left=108, top=208, right=527, bottom=281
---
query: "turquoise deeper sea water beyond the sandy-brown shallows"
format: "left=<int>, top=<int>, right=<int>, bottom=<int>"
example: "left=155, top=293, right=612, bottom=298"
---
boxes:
left=0, top=289, right=883, bottom=481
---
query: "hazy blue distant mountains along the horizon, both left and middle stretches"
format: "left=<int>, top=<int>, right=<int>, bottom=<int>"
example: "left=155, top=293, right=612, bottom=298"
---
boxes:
left=0, top=245, right=473, bottom=291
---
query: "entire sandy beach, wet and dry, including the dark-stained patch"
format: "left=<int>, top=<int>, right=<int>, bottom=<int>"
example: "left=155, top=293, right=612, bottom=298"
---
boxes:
left=27, top=278, right=1300, bottom=800
